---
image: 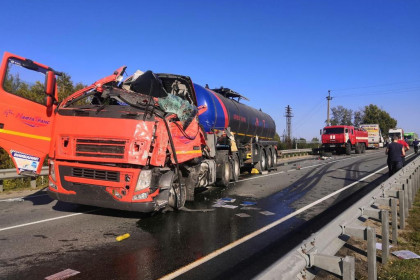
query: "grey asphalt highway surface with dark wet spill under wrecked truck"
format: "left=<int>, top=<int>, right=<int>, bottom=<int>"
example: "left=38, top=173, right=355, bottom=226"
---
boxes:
left=0, top=150, right=412, bottom=279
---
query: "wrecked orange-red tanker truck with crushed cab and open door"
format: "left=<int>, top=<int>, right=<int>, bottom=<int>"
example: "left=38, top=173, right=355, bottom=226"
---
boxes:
left=0, top=53, right=277, bottom=212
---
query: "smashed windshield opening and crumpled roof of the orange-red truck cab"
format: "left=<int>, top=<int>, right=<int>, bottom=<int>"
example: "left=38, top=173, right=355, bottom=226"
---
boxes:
left=63, top=70, right=198, bottom=127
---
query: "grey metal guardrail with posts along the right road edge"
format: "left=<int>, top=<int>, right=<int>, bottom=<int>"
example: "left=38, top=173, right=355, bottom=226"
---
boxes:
left=256, top=157, right=420, bottom=280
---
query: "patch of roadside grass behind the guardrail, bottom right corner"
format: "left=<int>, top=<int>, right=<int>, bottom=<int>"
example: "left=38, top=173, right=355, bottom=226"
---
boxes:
left=378, top=193, right=420, bottom=280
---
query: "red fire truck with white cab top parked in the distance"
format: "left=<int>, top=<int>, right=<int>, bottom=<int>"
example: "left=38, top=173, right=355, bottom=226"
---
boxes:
left=321, top=125, right=368, bottom=155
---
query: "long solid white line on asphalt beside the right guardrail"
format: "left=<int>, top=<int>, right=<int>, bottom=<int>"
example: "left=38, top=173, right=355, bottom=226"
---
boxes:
left=160, top=163, right=388, bottom=280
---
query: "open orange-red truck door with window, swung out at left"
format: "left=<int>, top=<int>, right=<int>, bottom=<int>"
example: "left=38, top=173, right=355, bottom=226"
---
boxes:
left=0, top=52, right=57, bottom=174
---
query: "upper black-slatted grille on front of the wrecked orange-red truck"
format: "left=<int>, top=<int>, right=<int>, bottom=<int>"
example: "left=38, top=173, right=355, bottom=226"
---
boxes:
left=76, top=139, right=126, bottom=158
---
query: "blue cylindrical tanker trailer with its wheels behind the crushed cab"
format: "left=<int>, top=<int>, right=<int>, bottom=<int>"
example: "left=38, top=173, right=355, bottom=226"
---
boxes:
left=194, top=84, right=277, bottom=185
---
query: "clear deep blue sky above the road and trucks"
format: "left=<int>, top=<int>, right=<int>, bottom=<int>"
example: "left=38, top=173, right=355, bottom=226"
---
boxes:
left=0, top=0, right=420, bottom=140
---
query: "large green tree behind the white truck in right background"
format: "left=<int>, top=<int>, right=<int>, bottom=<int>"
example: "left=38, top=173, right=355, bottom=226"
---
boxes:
left=363, top=104, right=397, bottom=136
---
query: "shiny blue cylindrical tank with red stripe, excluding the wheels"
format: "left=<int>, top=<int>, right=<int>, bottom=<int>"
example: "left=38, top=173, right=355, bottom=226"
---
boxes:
left=194, top=84, right=276, bottom=143
